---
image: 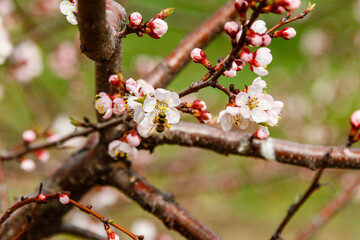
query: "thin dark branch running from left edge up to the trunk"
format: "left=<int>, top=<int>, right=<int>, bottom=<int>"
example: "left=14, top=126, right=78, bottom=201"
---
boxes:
left=0, top=117, right=125, bottom=161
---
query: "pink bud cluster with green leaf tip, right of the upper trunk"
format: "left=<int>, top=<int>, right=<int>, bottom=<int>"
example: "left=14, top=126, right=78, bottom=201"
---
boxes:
left=125, top=8, right=174, bottom=39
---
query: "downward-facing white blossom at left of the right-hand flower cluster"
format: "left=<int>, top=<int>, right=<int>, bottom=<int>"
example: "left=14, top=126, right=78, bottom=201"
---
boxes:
left=217, top=106, right=249, bottom=131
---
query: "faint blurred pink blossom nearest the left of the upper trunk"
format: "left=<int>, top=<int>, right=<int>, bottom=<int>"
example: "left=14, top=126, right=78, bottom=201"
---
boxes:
left=49, top=41, right=78, bottom=78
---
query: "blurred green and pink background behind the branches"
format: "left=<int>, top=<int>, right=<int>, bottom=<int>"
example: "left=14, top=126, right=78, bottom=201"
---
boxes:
left=0, top=0, right=360, bottom=240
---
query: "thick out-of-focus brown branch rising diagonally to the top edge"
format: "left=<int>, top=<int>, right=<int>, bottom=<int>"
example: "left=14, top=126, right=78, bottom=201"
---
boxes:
left=145, top=0, right=237, bottom=88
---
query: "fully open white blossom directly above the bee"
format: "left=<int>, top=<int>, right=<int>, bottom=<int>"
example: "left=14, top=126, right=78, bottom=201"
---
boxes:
left=143, top=88, right=180, bottom=123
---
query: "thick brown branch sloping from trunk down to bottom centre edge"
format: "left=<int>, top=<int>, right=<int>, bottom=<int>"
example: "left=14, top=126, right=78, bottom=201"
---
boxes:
left=107, top=168, right=220, bottom=240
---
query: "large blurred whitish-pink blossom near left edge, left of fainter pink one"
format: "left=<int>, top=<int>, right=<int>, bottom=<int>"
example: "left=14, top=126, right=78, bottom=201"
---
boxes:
left=10, top=40, right=43, bottom=82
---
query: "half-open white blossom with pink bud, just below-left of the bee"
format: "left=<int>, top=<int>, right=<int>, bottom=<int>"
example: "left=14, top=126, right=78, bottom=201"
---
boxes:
left=108, top=130, right=141, bottom=158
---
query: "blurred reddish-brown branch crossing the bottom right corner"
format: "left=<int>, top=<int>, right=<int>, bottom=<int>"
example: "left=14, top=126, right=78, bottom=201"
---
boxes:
left=296, top=175, right=360, bottom=240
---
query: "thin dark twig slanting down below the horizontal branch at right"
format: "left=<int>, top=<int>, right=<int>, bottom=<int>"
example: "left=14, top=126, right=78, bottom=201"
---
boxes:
left=271, top=149, right=331, bottom=240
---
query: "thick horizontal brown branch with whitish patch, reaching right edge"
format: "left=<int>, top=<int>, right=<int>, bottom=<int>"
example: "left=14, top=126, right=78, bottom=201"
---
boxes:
left=142, top=122, right=360, bottom=170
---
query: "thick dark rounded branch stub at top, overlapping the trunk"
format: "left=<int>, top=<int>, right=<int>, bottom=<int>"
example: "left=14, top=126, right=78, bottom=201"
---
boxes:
left=77, top=0, right=126, bottom=62
